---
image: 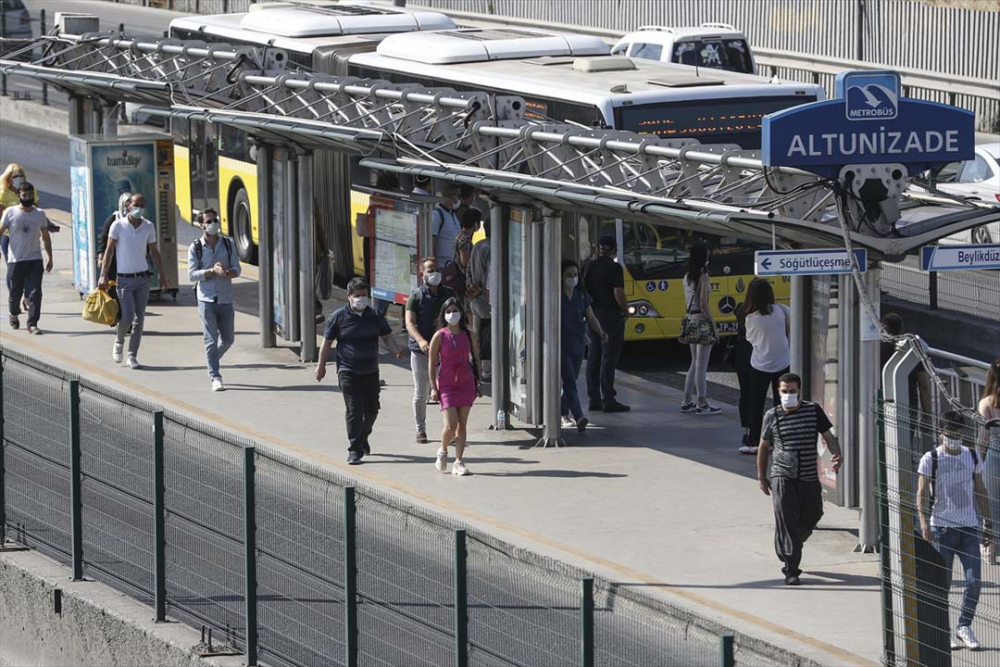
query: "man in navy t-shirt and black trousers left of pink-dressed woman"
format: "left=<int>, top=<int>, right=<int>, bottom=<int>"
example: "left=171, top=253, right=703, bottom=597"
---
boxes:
left=316, top=278, right=403, bottom=465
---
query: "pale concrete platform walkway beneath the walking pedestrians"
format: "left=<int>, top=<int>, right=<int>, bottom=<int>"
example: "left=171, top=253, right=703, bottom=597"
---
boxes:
left=0, top=211, right=881, bottom=666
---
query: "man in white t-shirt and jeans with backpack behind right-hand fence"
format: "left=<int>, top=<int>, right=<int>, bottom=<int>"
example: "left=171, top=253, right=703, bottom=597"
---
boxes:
left=917, top=412, right=993, bottom=650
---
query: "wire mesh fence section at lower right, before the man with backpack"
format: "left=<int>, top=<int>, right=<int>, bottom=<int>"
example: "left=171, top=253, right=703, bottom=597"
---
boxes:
left=876, top=378, right=1000, bottom=667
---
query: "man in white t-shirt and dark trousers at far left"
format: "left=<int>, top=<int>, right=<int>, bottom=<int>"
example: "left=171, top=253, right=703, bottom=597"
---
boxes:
left=0, top=182, right=52, bottom=334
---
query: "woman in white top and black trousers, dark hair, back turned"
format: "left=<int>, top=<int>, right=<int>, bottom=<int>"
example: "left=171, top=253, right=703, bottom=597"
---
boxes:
left=743, top=278, right=792, bottom=454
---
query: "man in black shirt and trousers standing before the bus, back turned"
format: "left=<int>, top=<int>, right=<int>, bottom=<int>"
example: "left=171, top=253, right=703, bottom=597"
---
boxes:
left=583, top=235, right=630, bottom=412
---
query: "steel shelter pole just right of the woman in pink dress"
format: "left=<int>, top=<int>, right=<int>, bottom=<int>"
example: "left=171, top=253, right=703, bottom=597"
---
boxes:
left=489, top=202, right=513, bottom=429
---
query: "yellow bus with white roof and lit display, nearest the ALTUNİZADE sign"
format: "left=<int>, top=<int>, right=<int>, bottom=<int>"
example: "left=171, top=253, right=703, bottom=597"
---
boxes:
left=348, top=27, right=812, bottom=340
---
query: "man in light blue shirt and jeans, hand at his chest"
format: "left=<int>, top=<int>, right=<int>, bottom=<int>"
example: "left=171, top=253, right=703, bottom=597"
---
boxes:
left=188, top=209, right=240, bottom=391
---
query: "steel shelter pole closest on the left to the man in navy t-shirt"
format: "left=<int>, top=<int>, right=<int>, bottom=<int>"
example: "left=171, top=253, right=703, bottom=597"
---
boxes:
left=298, top=153, right=317, bottom=363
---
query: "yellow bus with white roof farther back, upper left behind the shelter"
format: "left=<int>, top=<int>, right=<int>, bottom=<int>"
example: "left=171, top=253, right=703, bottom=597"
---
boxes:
left=170, top=2, right=455, bottom=274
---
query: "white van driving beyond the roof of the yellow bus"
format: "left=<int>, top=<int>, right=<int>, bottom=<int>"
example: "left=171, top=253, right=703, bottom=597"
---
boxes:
left=611, top=23, right=757, bottom=74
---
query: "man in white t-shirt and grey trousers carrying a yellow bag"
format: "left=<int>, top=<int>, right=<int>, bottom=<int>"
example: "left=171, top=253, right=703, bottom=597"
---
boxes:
left=98, top=193, right=167, bottom=370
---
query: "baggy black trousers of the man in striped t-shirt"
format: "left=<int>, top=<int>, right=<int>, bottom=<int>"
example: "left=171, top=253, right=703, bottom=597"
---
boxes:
left=771, top=477, right=823, bottom=577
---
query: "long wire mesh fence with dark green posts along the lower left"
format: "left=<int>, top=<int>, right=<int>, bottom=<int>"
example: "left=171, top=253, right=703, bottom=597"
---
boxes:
left=0, top=348, right=772, bottom=667
